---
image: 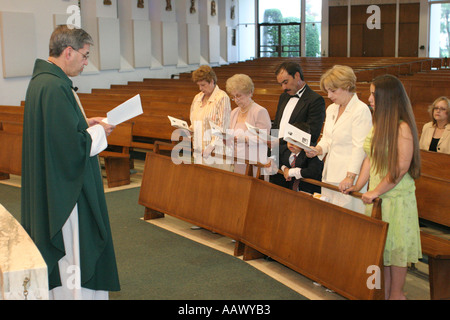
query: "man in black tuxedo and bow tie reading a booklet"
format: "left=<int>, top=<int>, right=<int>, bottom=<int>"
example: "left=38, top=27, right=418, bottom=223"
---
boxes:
left=270, top=61, right=325, bottom=186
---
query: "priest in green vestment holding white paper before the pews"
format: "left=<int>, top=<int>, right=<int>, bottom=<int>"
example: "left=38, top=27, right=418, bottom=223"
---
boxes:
left=22, top=26, right=120, bottom=299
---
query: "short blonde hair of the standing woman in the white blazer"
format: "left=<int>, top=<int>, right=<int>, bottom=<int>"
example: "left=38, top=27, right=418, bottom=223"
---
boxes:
left=320, top=65, right=356, bottom=93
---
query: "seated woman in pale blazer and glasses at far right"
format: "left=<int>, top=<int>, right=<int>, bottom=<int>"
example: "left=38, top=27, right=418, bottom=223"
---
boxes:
left=419, top=97, right=450, bottom=154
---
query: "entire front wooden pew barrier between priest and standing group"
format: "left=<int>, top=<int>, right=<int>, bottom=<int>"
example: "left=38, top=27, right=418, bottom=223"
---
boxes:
left=139, top=152, right=387, bottom=299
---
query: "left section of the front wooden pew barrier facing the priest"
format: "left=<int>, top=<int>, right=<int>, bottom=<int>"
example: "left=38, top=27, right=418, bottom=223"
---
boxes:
left=139, top=152, right=252, bottom=240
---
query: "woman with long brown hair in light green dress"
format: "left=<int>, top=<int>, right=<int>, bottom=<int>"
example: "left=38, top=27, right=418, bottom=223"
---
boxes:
left=345, top=75, right=422, bottom=299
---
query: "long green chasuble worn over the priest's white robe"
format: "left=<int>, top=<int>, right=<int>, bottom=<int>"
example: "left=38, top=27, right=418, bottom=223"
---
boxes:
left=22, top=59, right=120, bottom=291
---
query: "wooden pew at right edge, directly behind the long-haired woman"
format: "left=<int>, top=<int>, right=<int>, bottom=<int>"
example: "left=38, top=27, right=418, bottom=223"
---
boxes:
left=416, top=150, right=450, bottom=300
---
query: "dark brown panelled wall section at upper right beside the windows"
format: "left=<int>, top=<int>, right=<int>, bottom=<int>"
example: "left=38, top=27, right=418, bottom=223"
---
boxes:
left=328, top=0, right=429, bottom=57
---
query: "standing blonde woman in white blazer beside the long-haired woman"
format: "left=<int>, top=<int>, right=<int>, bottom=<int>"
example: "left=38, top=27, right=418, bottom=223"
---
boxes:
left=307, top=65, right=372, bottom=213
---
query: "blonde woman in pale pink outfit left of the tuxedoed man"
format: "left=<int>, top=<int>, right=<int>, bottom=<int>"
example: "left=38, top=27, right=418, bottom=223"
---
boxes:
left=226, top=74, right=271, bottom=176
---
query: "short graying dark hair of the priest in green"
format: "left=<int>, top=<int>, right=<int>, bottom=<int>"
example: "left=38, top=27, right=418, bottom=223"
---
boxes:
left=49, top=25, right=94, bottom=58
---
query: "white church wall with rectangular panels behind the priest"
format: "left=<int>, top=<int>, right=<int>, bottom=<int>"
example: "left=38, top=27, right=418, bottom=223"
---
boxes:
left=0, top=0, right=239, bottom=105
